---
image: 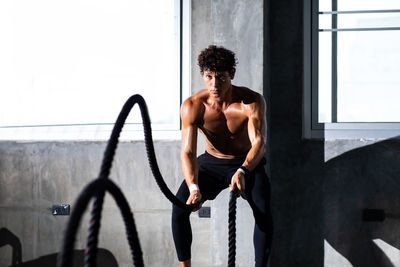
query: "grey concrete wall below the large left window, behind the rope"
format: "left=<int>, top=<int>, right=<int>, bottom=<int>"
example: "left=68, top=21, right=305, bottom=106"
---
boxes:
left=0, top=141, right=200, bottom=266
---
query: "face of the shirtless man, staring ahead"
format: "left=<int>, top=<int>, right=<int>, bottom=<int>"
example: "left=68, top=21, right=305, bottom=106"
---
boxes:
left=203, top=70, right=235, bottom=99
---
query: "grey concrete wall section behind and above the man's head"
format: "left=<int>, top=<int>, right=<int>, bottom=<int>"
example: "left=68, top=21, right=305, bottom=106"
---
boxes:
left=191, top=0, right=264, bottom=96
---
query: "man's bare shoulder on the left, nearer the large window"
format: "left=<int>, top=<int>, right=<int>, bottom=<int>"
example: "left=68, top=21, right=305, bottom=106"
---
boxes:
left=181, top=90, right=207, bottom=124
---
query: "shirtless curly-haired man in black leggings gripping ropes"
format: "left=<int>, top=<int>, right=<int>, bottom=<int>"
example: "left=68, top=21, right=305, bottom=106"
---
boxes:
left=172, top=46, right=272, bottom=266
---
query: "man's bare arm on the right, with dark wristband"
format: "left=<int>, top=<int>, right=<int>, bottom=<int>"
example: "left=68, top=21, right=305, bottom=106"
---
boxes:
left=230, top=95, right=267, bottom=193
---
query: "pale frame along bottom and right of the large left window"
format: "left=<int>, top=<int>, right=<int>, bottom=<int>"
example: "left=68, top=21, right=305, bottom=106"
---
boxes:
left=0, top=0, right=191, bottom=141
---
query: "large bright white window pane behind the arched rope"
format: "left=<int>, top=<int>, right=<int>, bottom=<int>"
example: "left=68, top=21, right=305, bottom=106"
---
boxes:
left=0, top=0, right=189, bottom=139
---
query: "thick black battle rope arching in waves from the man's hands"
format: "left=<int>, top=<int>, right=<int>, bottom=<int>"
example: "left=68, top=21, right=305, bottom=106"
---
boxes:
left=58, top=95, right=236, bottom=267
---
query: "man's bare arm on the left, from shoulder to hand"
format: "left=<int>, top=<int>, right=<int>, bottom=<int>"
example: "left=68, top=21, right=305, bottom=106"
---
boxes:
left=181, top=98, right=201, bottom=208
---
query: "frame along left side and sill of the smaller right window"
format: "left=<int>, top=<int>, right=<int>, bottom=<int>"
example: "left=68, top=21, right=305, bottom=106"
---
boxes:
left=303, top=0, right=400, bottom=140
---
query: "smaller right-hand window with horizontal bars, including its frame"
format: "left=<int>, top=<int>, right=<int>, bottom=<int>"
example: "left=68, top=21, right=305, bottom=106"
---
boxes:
left=305, top=0, right=400, bottom=138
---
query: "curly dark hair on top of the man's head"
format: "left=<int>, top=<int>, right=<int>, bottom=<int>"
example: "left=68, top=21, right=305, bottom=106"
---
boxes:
left=197, top=45, right=237, bottom=73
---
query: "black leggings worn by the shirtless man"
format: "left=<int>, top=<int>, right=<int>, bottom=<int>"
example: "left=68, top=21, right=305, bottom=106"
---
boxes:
left=172, top=152, right=272, bottom=266
